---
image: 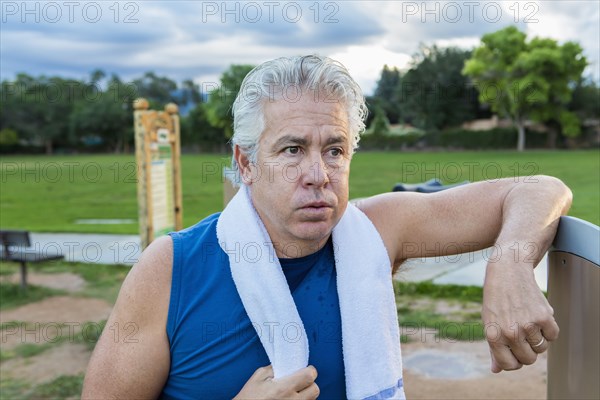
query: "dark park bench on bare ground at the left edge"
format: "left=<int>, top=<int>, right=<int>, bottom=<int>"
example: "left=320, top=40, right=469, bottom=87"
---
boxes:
left=0, top=230, right=64, bottom=289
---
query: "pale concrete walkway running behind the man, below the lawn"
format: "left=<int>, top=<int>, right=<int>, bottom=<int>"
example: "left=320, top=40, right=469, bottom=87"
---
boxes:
left=19, top=233, right=548, bottom=290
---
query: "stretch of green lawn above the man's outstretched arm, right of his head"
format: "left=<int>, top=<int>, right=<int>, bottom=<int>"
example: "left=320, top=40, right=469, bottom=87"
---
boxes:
left=350, top=150, right=600, bottom=225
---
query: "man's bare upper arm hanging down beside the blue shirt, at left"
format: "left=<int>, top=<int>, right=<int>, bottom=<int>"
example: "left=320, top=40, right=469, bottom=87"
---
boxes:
left=82, top=236, right=173, bottom=399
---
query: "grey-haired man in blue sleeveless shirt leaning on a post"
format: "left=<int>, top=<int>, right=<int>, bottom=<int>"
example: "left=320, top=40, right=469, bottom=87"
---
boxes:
left=83, top=56, right=571, bottom=399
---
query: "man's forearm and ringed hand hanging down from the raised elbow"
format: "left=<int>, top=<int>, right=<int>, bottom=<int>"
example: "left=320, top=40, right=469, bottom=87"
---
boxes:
left=482, top=177, right=572, bottom=372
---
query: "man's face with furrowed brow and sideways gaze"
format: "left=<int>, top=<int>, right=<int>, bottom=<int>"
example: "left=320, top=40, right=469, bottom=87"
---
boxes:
left=240, top=93, right=351, bottom=257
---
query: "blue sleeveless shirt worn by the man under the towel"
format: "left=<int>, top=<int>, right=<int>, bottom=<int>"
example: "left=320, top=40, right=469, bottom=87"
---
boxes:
left=161, top=214, right=346, bottom=400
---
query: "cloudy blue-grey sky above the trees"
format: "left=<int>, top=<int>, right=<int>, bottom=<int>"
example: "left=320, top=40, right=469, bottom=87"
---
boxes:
left=0, top=0, right=600, bottom=94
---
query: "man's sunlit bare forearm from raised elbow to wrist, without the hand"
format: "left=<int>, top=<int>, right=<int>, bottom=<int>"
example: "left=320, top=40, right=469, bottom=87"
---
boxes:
left=496, top=176, right=572, bottom=266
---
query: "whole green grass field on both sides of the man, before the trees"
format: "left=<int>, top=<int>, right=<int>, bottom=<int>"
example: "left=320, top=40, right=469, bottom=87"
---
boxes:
left=0, top=151, right=600, bottom=234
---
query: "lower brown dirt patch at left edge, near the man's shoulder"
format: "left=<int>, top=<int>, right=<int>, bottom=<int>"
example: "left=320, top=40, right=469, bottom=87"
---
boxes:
left=0, top=343, right=92, bottom=384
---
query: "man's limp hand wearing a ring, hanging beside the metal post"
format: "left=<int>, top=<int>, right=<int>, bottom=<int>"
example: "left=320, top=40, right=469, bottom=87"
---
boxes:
left=481, top=262, right=559, bottom=373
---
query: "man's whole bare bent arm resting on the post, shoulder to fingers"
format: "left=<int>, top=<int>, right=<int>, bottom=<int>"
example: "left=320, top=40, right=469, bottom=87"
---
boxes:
left=357, top=176, right=572, bottom=372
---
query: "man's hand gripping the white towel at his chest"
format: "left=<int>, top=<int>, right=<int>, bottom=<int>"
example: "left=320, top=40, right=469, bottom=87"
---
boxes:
left=234, top=365, right=320, bottom=400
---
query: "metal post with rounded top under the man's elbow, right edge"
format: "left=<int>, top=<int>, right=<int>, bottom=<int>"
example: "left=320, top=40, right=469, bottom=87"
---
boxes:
left=548, top=217, right=600, bottom=400
